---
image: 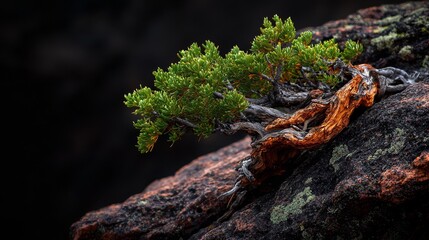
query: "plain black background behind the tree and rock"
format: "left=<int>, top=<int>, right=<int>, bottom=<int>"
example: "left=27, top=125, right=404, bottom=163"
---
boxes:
left=5, top=0, right=410, bottom=239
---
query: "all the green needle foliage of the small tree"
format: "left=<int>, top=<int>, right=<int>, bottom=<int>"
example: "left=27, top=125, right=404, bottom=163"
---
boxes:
left=125, top=15, right=362, bottom=152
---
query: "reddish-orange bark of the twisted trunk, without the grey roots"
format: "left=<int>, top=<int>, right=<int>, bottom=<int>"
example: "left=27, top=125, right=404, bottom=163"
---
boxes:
left=242, top=64, right=379, bottom=185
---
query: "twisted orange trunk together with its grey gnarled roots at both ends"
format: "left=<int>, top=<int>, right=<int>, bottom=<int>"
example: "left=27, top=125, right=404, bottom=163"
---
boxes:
left=222, top=64, right=419, bottom=199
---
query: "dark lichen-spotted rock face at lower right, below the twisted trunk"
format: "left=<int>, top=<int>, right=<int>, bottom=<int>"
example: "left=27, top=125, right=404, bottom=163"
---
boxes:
left=192, top=79, right=429, bottom=239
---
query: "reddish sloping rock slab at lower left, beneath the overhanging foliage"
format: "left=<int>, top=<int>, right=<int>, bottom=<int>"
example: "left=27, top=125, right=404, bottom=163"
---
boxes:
left=72, top=139, right=250, bottom=239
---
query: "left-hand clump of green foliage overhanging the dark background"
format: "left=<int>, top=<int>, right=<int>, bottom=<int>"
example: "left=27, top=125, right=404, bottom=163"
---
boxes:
left=125, top=41, right=248, bottom=152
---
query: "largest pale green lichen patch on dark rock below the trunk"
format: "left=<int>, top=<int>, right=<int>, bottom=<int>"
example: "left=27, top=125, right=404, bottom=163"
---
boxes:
left=270, top=187, right=316, bottom=224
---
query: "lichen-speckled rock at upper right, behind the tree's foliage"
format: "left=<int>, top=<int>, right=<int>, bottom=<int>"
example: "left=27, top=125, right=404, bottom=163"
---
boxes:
left=304, top=1, right=429, bottom=69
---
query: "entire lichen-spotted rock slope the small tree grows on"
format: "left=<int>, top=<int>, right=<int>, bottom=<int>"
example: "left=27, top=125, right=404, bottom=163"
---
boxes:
left=71, top=2, right=429, bottom=240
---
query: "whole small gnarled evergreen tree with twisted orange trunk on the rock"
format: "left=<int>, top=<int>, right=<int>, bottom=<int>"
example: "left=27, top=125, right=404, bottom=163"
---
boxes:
left=125, top=15, right=417, bottom=195
